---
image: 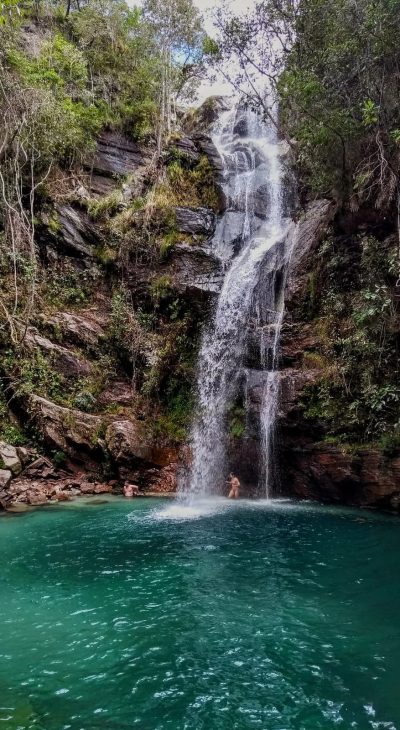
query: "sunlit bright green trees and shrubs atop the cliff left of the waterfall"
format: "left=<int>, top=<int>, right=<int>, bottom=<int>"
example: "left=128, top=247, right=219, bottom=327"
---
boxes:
left=0, top=0, right=202, bottom=345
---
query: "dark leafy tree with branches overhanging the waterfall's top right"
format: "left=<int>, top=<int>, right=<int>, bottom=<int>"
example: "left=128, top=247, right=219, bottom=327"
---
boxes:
left=211, top=0, right=400, bottom=208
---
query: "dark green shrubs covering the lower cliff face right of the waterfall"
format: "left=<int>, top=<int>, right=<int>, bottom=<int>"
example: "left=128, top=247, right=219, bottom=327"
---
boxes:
left=303, top=236, right=400, bottom=443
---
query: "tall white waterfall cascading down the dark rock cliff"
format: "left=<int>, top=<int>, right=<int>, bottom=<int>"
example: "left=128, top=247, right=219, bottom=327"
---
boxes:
left=185, top=105, right=287, bottom=495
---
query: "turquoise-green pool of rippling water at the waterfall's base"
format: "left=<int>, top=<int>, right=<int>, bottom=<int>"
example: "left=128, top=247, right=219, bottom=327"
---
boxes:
left=0, top=499, right=400, bottom=730
